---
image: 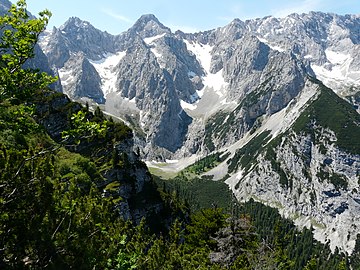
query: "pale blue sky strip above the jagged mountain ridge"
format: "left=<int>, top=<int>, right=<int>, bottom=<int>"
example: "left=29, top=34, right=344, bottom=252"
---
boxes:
left=11, top=0, right=360, bottom=34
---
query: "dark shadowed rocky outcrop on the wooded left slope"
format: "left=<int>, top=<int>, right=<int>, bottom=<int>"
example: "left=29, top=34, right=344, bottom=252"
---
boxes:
left=32, top=91, right=166, bottom=226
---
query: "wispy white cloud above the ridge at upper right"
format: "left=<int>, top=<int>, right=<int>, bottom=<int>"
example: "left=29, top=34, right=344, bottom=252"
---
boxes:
left=272, top=0, right=325, bottom=17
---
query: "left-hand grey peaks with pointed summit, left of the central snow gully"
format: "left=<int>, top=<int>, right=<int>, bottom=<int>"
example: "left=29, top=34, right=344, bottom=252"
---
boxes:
left=40, top=15, right=202, bottom=155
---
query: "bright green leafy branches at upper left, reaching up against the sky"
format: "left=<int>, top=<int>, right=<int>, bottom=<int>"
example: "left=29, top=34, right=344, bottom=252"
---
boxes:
left=0, top=0, right=56, bottom=101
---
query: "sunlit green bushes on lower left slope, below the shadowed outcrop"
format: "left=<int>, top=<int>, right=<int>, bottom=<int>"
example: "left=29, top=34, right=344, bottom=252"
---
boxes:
left=0, top=104, right=134, bottom=269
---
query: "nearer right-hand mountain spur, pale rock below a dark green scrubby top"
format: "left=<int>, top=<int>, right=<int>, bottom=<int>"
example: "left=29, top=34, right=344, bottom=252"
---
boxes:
left=226, top=87, right=360, bottom=254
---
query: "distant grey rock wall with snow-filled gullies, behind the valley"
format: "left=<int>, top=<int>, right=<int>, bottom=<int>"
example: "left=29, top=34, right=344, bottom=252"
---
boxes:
left=40, top=13, right=359, bottom=159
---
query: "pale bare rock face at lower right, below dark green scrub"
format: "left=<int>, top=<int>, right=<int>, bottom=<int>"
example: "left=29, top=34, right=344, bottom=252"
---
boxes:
left=227, top=126, right=360, bottom=254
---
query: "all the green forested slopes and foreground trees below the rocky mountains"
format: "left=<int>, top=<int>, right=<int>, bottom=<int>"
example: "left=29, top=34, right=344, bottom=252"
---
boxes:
left=0, top=0, right=360, bottom=270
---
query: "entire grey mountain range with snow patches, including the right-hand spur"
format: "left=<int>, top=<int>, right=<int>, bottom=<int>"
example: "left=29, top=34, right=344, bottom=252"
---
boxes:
left=1, top=0, right=360, bottom=254
